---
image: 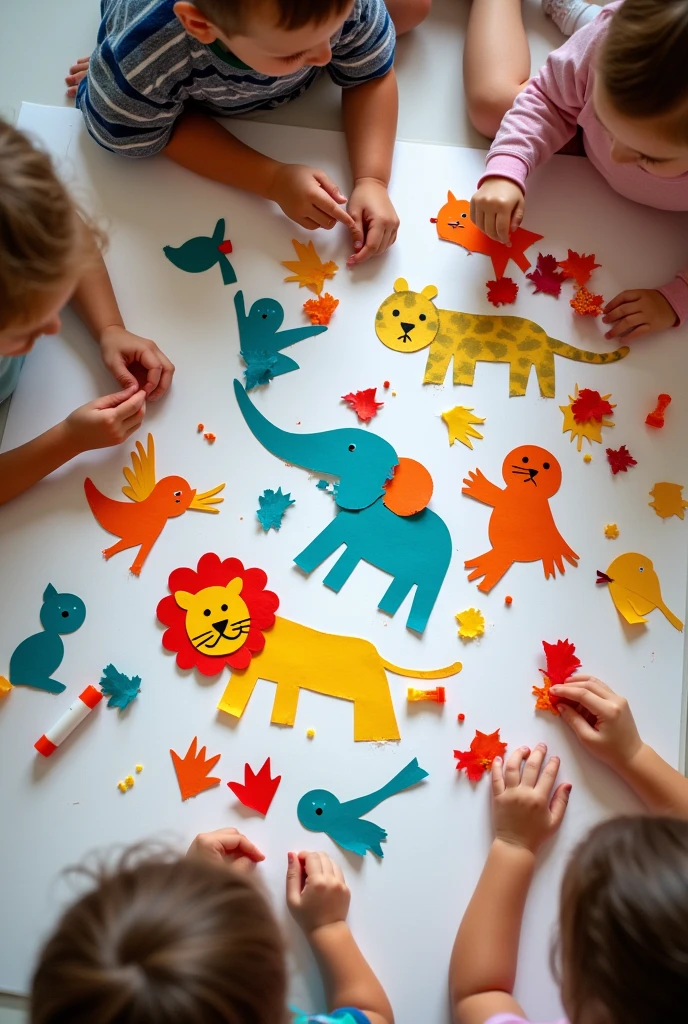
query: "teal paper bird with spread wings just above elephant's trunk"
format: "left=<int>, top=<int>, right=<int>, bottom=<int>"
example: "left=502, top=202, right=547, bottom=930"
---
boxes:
left=234, top=290, right=328, bottom=391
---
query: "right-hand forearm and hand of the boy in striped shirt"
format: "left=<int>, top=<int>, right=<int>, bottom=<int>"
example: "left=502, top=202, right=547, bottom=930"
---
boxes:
left=342, top=68, right=399, bottom=266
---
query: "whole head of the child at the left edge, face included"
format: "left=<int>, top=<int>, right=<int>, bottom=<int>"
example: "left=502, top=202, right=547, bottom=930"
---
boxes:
left=0, top=121, right=88, bottom=355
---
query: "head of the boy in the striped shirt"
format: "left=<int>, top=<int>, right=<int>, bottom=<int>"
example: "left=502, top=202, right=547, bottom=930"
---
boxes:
left=174, top=0, right=353, bottom=76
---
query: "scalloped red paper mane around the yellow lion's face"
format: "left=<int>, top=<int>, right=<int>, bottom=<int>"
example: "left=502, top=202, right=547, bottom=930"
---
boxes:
left=157, top=552, right=280, bottom=676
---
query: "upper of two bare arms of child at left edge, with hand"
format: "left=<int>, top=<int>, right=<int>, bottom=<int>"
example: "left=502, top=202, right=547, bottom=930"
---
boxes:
left=72, top=239, right=174, bottom=401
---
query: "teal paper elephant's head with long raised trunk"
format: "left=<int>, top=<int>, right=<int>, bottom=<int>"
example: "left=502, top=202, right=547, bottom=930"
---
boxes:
left=234, top=380, right=398, bottom=509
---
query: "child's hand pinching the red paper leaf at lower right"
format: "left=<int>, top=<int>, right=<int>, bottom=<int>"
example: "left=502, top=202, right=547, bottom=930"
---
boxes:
left=552, top=676, right=643, bottom=771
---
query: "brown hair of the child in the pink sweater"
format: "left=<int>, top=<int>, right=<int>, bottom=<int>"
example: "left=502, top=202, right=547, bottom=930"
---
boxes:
left=597, top=0, right=688, bottom=142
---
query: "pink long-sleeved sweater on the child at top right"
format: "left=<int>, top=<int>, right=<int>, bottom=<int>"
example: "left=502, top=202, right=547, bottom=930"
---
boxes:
left=480, top=2, right=688, bottom=323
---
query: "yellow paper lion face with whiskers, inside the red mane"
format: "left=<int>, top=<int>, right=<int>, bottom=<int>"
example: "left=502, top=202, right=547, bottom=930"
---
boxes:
left=174, top=577, right=251, bottom=657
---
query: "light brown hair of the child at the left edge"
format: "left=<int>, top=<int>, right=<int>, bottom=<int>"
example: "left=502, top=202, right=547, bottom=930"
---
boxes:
left=0, top=120, right=96, bottom=328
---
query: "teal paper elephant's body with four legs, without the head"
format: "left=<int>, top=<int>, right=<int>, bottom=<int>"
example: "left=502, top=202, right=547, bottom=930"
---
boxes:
left=294, top=501, right=452, bottom=633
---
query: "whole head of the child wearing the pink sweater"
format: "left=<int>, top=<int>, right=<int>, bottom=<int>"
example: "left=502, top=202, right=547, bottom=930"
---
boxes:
left=594, top=0, right=688, bottom=178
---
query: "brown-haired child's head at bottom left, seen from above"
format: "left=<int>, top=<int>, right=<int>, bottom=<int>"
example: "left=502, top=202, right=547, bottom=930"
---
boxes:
left=31, top=853, right=287, bottom=1024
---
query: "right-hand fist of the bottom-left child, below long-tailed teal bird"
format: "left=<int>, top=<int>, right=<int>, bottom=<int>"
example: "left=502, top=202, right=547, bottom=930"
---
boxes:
left=287, top=851, right=351, bottom=934
